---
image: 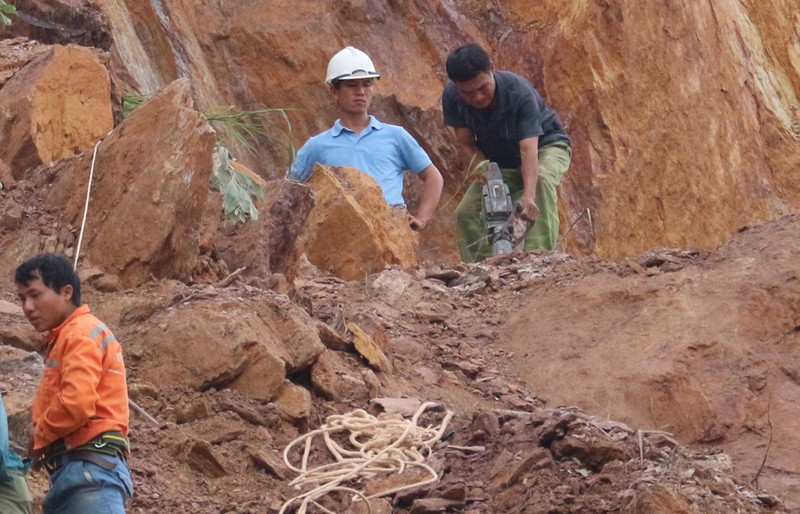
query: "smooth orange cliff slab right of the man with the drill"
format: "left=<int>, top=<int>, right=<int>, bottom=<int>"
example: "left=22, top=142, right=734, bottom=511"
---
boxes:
left=520, top=0, right=800, bottom=257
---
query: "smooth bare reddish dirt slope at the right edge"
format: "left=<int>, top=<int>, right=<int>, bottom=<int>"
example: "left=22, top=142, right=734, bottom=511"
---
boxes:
left=502, top=217, right=800, bottom=508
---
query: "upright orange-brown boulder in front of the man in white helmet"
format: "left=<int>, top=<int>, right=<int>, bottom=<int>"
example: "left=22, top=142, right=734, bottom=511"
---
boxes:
left=301, top=165, right=419, bottom=280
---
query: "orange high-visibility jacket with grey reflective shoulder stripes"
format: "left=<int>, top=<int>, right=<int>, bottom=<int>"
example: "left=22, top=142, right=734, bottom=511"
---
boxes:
left=32, top=305, right=130, bottom=450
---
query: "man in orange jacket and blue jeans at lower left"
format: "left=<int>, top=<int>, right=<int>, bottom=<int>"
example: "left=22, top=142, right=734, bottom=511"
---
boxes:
left=15, top=254, right=133, bottom=514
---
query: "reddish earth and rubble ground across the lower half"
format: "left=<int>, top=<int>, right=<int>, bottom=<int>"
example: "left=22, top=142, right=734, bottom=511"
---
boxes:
left=0, top=217, right=800, bottom=513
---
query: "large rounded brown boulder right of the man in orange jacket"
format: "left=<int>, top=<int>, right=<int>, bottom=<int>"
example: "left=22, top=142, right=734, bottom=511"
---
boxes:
left=130, top=295, right=325, bottom=400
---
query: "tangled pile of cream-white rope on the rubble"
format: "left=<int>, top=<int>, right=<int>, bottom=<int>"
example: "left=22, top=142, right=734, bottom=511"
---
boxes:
left=279, top=402, right=453, bottom=514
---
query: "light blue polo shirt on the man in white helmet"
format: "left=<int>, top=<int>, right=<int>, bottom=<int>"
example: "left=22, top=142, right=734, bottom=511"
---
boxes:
left=286, top=116, right=431, bottom=205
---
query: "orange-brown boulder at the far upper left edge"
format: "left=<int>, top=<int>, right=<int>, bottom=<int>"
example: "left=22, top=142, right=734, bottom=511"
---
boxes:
left=0, top=46, right=113, bottom=182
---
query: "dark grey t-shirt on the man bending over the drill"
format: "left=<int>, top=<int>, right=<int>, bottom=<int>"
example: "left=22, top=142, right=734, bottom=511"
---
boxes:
left=442, top=71, right=571, bottom=168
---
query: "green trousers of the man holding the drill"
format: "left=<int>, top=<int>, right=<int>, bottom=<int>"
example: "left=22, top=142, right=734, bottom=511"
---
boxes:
left=456, top=143, right=572, bottom=262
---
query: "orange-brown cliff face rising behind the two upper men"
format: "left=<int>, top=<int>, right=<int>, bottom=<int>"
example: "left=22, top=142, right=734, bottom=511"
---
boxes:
left=4, top=0, right=800, bottom=258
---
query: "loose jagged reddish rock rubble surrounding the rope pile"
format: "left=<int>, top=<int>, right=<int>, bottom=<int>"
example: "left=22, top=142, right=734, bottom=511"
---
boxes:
left=3, top=222, right=788, bottom=514
